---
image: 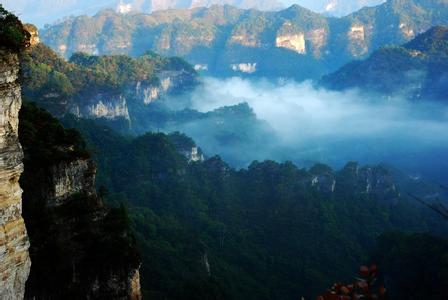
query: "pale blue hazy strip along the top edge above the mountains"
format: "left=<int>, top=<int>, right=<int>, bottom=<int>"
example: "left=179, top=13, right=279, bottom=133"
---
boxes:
left=2, top=0, right=385, bottom=27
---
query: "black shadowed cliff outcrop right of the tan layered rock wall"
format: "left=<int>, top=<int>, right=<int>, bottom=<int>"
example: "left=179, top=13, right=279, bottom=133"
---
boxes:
left=20, top=105, right=141, bottom=299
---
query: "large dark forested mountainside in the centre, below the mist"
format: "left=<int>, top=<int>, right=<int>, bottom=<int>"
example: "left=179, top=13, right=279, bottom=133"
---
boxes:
left=60, top=113, right=447, bottom=299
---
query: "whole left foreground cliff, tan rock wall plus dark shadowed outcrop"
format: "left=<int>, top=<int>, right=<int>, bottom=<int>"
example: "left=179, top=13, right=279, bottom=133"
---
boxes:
left=0, top=5, right=141, bottom=300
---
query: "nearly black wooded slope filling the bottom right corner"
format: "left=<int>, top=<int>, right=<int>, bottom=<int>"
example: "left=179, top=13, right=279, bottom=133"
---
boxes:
left=373, top=232, right=448, bottom=300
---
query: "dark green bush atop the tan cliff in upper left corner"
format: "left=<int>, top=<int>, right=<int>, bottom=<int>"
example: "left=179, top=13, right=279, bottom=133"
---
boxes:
left=0, top=4, right=30, bottom=51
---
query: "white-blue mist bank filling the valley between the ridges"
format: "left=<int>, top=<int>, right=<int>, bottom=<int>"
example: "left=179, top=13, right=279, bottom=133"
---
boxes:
left=167, top=78, right=448, bottom=178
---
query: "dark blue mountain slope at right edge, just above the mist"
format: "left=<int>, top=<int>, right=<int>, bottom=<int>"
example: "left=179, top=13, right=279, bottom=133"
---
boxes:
left=321, top=26, right=448, bottom=101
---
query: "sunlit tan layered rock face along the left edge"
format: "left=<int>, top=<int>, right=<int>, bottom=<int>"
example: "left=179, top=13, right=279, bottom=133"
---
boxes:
left=0, top=49, right=31, bottom=299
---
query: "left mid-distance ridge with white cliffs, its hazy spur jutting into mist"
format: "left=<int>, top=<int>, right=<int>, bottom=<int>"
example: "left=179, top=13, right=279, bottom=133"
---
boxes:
left=21, top=34, right=276, bottom=166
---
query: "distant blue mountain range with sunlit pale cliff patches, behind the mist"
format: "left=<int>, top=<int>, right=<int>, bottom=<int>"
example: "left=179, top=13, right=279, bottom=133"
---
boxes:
left=42, top=0, right=448, bottom=80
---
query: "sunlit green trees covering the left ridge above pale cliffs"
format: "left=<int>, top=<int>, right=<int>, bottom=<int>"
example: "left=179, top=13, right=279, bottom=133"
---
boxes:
left=21, top=44, right=196, bottom=116
